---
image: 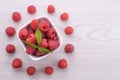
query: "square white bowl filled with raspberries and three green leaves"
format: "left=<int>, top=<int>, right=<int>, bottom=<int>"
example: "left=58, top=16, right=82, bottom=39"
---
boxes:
left=18, top=17, right=62, bottom=60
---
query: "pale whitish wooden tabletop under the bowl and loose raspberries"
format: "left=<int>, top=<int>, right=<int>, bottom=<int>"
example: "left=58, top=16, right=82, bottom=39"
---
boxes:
left=0, top=0, right=120, bottom=80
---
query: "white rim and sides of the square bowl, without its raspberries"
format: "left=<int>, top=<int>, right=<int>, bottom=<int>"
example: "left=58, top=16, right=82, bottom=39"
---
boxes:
left=17, top=16, right=62, bottom=60
